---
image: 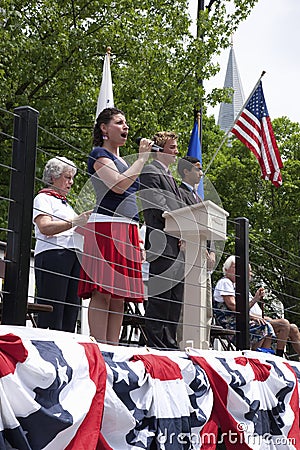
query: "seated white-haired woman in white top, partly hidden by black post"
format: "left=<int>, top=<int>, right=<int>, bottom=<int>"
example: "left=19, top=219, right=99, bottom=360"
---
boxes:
left=214, top=256, right=275, bottom=350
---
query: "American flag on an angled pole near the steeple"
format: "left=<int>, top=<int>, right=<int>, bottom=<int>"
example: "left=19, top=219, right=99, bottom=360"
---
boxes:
left=231, top=81, right=283, bottom=187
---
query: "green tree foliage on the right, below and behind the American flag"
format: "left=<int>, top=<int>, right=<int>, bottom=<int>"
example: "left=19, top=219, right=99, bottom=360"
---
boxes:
left=209, top=117, right=300, bottom=325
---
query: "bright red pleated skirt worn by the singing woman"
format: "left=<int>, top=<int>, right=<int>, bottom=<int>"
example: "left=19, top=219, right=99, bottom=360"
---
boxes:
left=78, top=222, right=144, bottom=302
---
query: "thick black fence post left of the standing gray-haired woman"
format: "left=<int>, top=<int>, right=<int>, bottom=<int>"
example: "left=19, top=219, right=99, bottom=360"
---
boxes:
left=2, top=106, right=39, bottom=325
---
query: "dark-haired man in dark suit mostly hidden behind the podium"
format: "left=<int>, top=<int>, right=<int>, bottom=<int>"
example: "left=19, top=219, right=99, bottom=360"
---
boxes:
left=177, top=156, right=216, bottom=342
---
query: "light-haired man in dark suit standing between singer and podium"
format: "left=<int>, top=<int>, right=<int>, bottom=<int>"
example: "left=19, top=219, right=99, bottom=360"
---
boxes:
left=140, top=132, right=184, bottom=348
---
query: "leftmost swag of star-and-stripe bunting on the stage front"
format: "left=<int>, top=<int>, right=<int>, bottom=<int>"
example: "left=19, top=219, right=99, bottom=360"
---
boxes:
left=0, top=327, right=110, bottom=450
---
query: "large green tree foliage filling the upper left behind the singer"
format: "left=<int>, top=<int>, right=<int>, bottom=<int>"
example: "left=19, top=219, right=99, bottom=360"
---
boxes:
left=0, top=0, right=257, bottom=237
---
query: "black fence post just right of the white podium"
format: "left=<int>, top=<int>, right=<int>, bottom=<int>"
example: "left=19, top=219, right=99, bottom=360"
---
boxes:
left=235, top=217, right=250, bottom=350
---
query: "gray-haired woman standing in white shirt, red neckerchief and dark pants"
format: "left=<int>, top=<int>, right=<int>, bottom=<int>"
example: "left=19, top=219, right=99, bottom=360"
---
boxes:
left=33, top=157, right=90, bottom=332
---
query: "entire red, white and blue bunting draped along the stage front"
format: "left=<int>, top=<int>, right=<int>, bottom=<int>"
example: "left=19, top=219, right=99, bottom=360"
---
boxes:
left=0, top=326, right=300, bottom=450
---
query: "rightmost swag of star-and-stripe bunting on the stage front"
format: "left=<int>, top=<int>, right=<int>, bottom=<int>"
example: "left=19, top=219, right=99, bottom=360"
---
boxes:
left=190, top=350, right=300, bottom=450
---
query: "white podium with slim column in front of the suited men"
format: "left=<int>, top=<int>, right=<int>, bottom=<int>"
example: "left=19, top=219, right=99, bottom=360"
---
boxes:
left=163, top=200, right=229, bottom=349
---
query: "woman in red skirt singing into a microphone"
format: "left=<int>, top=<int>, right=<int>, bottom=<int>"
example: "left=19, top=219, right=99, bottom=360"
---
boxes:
left=79, top=108, right=152, bottom=344
